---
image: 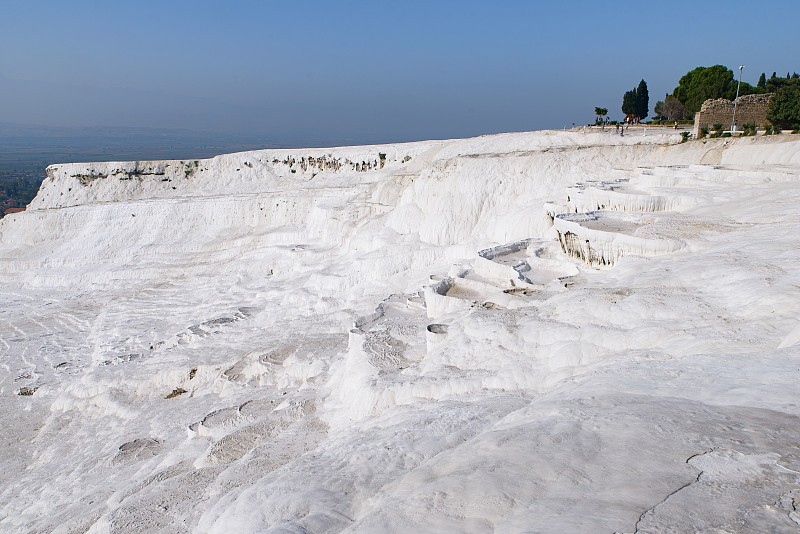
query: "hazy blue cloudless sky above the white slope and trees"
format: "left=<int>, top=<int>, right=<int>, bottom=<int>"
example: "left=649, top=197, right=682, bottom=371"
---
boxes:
left=0, top=0, right=800, bottom=142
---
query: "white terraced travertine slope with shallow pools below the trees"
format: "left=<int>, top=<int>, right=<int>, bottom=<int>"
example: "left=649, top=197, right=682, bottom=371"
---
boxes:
left=0, top=130, right=800, bottom=533
